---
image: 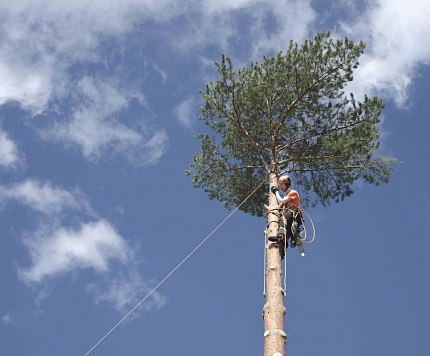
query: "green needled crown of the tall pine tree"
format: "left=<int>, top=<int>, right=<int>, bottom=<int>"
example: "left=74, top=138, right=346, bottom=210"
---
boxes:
left=186, top=32, right=396, bottom=216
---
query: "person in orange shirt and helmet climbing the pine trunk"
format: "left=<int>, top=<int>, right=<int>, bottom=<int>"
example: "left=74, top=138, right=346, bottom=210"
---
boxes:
left=269, top=175, right=303, bottom=247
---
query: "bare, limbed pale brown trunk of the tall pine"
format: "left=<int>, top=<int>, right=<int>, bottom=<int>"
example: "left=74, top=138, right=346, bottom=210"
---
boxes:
left=263, top=173, right=287, bottom=356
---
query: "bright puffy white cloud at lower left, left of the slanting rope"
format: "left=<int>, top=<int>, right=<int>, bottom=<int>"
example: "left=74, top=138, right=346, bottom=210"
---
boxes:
left=19, top=220, right=131, bottom=284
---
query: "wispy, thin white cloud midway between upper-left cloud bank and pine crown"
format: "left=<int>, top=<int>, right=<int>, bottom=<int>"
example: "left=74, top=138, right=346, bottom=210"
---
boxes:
left=35, top=77, right=168, bottom=165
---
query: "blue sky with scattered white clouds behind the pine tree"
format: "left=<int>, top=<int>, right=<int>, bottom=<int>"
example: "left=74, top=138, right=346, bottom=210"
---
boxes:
left=0, top=0, right=430, bottom=356
